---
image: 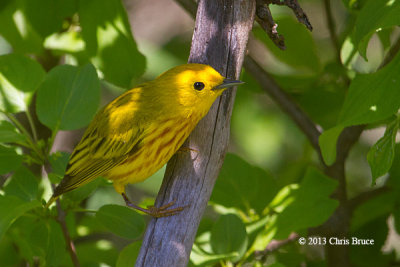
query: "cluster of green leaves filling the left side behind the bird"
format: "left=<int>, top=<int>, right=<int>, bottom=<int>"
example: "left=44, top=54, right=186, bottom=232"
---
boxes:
left=0, top=0, right=145, bottom=266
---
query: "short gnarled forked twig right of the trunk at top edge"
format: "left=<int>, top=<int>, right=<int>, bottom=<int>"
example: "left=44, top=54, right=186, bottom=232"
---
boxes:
left=256, top=0, right=312, bottom=50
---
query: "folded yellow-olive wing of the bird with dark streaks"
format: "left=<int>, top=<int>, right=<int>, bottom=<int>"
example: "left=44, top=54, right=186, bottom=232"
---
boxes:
left=53, top=91, right=146, bottom=197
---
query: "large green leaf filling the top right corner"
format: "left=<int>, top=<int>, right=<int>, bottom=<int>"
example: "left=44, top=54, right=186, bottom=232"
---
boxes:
left=353, top=0, right=400, bottom=59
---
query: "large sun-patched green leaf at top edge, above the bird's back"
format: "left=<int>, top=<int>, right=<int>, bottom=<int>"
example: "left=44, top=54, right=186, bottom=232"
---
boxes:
left=79, top=0, right=146, bottom=88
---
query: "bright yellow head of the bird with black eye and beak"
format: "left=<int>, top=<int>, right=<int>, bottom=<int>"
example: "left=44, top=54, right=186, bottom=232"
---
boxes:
left=154, top=64, right=242, bottom=117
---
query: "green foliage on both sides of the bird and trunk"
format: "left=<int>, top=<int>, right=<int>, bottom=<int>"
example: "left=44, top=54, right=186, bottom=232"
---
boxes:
left=0, top=0, right=400, bottom=267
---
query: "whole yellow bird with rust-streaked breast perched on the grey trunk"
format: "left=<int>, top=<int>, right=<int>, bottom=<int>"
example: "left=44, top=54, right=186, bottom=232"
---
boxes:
left=47, top=64, right=242, bottom=217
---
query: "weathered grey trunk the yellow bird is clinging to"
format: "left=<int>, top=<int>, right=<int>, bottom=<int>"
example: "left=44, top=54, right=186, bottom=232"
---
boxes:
left=136, top=0, right=255, bottom=267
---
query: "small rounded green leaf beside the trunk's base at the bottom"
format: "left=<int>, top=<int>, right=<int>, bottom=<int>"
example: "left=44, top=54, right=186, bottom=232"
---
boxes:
left=210, top=214, right=248, bottom=261
